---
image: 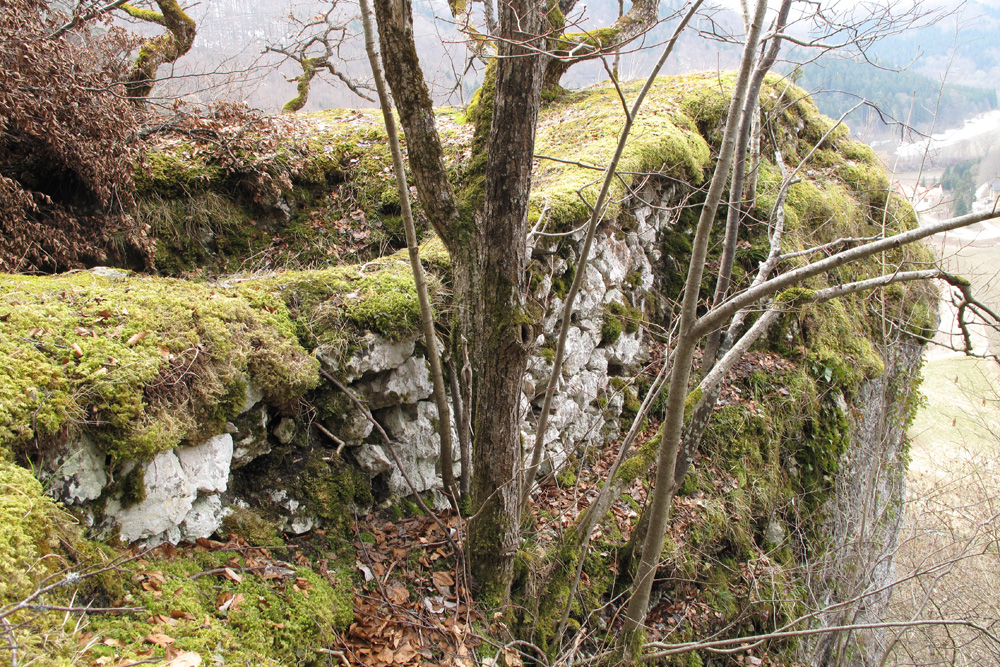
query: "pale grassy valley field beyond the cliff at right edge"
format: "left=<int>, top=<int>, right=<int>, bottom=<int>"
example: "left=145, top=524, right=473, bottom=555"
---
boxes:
left=889, top=230, right=1000, bottom=666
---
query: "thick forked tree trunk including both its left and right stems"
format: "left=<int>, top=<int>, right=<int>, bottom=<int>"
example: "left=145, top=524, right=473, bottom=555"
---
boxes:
left=375, top=0, right=546, bottom=602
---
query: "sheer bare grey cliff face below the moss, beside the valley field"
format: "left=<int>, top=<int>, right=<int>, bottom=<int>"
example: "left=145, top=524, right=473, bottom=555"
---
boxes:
left=801, top=339, right=924, bottom=667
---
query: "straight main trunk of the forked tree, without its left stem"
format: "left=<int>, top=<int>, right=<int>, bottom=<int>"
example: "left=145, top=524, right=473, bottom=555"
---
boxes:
left=462, top=0, right=545, bottom=603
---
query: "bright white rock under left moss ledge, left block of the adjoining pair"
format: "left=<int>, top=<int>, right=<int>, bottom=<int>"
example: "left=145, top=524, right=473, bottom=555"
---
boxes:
left=105, top=451, right=198, bottom=543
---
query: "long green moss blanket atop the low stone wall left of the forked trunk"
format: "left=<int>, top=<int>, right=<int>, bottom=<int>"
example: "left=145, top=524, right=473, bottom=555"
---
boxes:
left=0, top=243, right=440, bottom=462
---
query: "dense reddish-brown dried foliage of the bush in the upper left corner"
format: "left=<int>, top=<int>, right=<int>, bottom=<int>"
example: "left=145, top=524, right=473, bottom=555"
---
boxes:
left=0, top=0, right=153, bottom=272
